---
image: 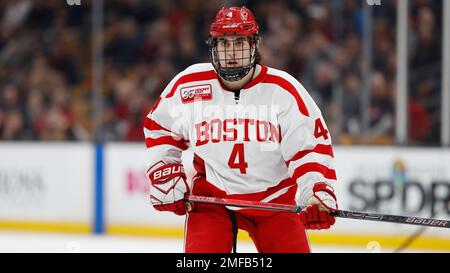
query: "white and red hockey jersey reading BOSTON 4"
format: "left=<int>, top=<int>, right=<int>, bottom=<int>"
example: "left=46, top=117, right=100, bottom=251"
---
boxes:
left=144, top=63, right=336, bottom=214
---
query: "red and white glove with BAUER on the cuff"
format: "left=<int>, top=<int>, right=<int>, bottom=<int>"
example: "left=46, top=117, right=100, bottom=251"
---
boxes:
left=147, top=162, right=191, bottom=215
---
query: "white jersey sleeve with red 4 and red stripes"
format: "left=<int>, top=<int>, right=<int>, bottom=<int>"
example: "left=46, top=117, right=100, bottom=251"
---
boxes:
left=278, top=79, right=336, bottom=206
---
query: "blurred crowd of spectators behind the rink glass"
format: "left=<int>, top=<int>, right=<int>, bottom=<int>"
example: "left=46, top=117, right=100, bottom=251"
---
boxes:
left=0, top=0, right=442, bottom=145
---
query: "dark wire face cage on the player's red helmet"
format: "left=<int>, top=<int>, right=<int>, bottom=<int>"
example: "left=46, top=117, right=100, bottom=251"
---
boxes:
left=208, top=35, right=259, bottom=81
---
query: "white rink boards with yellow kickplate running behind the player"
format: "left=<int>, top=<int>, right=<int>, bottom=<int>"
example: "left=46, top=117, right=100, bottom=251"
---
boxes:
left=0, top=142, right=450, bottom=251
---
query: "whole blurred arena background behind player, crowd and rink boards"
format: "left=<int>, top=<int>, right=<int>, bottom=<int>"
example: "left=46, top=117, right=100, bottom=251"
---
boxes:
left=0, top=0, right=450, bottom=252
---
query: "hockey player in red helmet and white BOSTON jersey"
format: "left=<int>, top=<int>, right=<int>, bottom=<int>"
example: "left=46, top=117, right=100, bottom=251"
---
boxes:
left=144, top=7, right=337, bottom=252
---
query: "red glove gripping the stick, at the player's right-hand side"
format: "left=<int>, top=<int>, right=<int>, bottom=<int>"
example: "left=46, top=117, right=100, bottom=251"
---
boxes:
left=300, top=182, right=338, bottom=229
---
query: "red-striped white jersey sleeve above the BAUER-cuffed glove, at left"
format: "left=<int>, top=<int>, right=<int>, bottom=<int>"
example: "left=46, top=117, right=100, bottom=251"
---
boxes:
left=144, top=73, right=189, bottom=173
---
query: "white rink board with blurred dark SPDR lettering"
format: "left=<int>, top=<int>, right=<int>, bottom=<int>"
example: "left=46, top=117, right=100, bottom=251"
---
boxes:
left=332, top=147, right=450, bottom=238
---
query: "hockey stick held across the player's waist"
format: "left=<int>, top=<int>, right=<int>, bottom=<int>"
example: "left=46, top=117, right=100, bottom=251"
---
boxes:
left=185, top=195, right=450, bottom=228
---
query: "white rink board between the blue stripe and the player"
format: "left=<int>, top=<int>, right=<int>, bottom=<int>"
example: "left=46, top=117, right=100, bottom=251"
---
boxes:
left=104, top=143, right=193, bottom=228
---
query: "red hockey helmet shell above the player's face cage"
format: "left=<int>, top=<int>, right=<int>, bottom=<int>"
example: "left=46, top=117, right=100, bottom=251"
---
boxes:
left=209, top=6, right=259, bottom=37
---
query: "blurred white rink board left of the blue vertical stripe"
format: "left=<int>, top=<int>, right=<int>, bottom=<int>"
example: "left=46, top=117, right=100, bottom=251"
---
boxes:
left=0, top=142, right=94, bottom=221
